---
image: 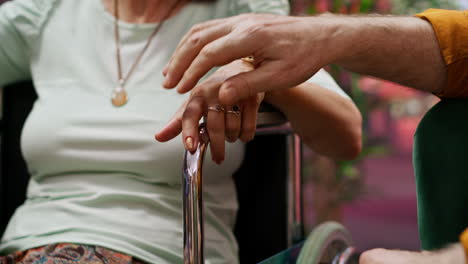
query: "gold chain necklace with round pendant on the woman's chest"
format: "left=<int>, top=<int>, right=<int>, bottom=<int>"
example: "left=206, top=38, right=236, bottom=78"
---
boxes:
left=111, top=0, right=179, bottom=107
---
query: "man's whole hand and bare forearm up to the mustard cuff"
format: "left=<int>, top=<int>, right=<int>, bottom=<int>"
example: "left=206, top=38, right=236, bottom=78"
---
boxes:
left=163, top=14, right=446, bottom=104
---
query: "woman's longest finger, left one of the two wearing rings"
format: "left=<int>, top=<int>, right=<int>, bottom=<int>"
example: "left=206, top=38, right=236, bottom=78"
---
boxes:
left=206, top=104, right=225, bottom=164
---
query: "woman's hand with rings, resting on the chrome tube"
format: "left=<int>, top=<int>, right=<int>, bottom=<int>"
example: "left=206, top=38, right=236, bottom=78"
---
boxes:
left=156, top=60, right=264, bottom=164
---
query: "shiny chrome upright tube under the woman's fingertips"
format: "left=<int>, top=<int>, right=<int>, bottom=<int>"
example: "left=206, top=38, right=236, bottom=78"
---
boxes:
left=182, top=124, right=209, bottom=264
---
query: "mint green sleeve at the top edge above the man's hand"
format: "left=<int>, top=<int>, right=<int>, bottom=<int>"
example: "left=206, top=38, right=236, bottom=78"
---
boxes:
left=230, top=0, right=290, bottom=16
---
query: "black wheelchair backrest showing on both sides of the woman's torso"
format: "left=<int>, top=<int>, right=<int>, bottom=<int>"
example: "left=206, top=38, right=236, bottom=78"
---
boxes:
left=0, top=82, right=287, bottom=263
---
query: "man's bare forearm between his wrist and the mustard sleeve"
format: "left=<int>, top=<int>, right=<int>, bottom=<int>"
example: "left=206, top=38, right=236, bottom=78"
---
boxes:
left=318, top=16, right=446, bottom=93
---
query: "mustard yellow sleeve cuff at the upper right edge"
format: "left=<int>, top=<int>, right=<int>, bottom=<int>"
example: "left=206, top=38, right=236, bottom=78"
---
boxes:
left=416, top=9, right=468, bottom=98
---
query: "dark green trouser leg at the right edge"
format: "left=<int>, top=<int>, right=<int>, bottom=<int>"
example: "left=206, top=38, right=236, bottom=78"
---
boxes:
left=413, top=99, right=468, bottom=250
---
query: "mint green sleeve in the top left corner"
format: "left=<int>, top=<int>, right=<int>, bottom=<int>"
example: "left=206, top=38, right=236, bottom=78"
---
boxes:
left=0, top=0, right=53, bottom=86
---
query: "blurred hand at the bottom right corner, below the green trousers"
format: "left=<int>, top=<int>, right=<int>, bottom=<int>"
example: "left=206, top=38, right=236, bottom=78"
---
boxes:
left=359, top=244, right=466, bottom=264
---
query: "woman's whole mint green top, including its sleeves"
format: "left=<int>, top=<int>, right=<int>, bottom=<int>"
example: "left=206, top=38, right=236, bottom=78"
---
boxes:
left=0, top=0, right=348, bottom=263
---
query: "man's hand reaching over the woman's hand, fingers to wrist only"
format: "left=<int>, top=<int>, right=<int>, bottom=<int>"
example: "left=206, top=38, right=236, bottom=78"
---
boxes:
left=163, top=14, right=333, bottom=104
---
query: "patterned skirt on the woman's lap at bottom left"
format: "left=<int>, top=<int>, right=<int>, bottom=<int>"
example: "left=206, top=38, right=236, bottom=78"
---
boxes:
left=0, top=243, right=145, bottom=264
